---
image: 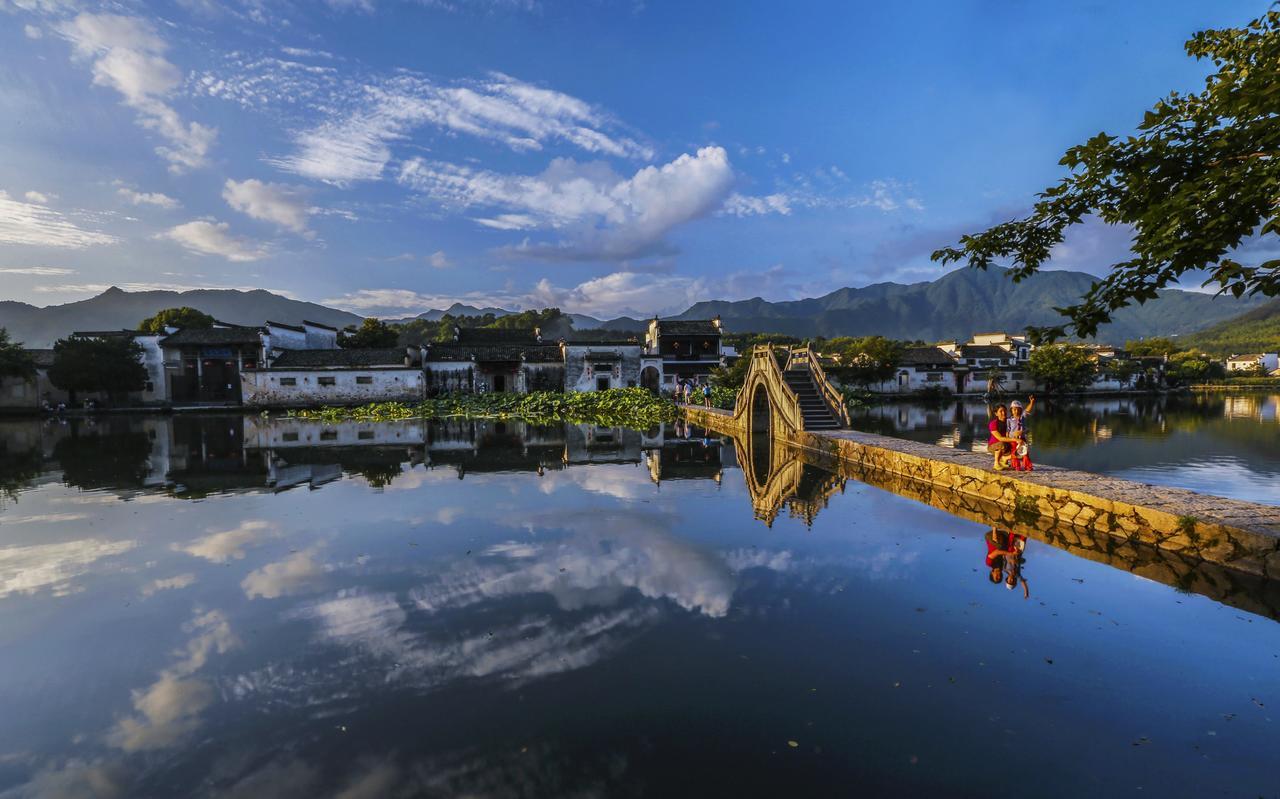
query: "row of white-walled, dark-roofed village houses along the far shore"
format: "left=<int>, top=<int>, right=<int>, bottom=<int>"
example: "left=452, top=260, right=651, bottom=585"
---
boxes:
left=0, top=312, right=1280, bottom=411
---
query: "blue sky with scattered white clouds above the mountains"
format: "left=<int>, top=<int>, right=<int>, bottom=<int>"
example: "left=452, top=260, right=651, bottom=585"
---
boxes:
left=0, top=0, right=1267, bottom=318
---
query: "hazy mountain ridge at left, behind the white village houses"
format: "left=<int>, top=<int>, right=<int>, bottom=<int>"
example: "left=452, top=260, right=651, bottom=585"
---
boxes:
left=0, top=287, right=361, bottom=347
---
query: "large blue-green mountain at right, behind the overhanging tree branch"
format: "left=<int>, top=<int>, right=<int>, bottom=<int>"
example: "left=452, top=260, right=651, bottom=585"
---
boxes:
left=675, top=268, right=1263, bottom=343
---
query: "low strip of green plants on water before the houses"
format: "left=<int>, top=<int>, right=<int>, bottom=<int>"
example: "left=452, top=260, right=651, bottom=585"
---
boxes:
left=289, top=388, right=676, bottom=428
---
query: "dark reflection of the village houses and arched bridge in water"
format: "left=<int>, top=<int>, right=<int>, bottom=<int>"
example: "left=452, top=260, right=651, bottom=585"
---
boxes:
left=0, top=414, right=844, bottom=525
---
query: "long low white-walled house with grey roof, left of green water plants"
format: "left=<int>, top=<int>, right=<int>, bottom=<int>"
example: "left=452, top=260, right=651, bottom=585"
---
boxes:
left=239, top=347, right=426, bottom=407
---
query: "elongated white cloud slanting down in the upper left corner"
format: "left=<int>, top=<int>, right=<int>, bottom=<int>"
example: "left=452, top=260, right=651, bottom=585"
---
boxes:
left=59, top=13, right=218, bottom=173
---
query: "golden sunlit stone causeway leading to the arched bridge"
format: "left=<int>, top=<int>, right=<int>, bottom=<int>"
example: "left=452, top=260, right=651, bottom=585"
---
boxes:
left=684, top=406, right=1280, bottom=579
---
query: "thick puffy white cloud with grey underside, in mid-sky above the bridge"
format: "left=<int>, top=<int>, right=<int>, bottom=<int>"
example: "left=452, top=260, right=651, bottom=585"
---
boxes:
left=399, top=147, right=733, bottom=260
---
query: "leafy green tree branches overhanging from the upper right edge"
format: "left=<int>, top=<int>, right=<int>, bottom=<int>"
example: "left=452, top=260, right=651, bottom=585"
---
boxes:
left=933, top=9, right=1280, bottom=342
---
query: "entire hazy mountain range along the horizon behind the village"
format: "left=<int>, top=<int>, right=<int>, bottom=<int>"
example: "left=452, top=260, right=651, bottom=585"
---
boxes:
left=0, top=269, right=1267, bottom=347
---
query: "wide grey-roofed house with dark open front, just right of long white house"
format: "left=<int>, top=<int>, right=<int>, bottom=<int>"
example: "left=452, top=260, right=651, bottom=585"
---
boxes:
left=422, top=328, right=564, bottom=394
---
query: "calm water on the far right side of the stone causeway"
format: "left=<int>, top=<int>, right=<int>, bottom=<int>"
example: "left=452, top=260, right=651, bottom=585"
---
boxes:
left=854, top=393, right=1280, bottom=504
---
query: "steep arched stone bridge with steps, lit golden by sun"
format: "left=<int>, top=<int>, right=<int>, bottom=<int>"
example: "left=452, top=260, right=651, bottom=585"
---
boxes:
left=733, top=344, right=849, bottom=439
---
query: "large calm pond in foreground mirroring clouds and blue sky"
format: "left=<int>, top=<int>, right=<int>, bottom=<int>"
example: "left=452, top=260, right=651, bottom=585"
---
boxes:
left=0, top=410, right=1280, bottom=798
